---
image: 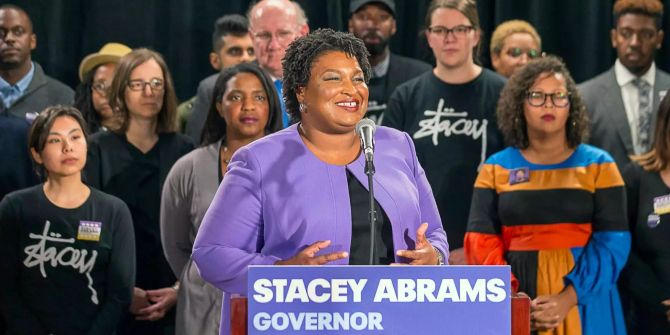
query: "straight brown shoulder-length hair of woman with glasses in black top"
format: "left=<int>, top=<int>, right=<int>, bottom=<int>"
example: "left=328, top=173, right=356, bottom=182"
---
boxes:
left=109, top=48, right=177, bottom=134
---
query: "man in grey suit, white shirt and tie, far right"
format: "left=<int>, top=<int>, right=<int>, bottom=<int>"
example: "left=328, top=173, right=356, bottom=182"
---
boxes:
left=578, top=0, right=670, bottom=169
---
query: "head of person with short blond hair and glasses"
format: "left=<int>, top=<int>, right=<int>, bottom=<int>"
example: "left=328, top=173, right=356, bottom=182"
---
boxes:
left=490, top=20, right=542, bottom=78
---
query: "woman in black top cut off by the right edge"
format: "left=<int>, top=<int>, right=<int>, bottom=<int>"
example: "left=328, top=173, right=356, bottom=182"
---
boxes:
left=619, top=95, right=670, bottom=335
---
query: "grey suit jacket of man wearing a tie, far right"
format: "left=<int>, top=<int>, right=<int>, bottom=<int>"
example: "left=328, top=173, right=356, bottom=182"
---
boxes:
left=578, top=67, right=670, bottom=171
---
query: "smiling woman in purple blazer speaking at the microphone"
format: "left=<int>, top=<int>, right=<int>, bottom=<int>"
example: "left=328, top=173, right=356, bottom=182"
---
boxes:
left=193, top=29, right=449, bottom=334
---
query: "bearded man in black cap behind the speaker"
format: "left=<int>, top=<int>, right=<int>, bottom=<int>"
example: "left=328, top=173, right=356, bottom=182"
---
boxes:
left=349, top=0, right=432, bottom=124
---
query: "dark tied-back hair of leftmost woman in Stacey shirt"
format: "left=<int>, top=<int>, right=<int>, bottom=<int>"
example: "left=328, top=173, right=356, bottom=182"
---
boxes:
left=28, top=105, right=88, bottom=177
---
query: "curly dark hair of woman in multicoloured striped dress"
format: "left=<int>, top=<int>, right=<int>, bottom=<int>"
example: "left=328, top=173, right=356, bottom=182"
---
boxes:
left=497, top=56, right=589, bottom=149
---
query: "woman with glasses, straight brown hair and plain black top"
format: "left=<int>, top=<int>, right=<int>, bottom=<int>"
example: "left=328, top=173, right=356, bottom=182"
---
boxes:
left=85, top=49, right=194, bottom=334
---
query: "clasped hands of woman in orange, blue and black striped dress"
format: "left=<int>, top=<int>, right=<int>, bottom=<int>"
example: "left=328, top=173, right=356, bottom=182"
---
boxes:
left=530, top=285, right=577, bottom=330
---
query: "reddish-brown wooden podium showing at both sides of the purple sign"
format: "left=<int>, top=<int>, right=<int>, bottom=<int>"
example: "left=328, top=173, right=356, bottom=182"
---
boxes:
left=230, top=297, right=530, bottom=335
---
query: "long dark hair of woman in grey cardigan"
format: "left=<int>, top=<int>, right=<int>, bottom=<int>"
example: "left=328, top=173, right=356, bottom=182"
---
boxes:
left=201, top=63, right=282, bottom=145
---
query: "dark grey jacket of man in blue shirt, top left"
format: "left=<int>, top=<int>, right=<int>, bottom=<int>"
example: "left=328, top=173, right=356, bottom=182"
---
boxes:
left=0, top=62, right=74, bottom=118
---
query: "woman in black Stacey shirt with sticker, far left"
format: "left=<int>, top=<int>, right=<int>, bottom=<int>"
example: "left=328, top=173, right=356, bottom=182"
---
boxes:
left=0, top=106, right=135, bottom=335
